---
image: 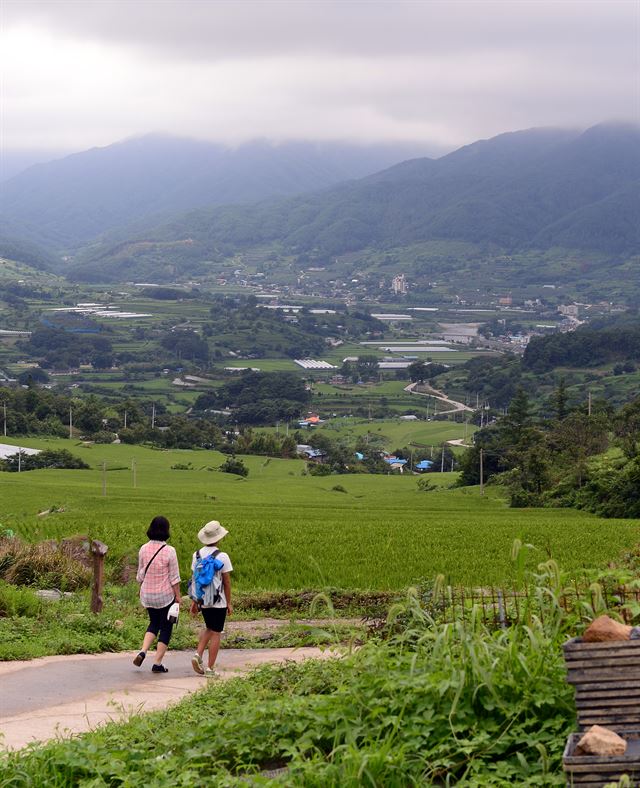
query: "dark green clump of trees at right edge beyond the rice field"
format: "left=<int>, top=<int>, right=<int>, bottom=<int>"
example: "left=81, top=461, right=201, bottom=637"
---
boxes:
left=461, top=384, right=640, bottom=517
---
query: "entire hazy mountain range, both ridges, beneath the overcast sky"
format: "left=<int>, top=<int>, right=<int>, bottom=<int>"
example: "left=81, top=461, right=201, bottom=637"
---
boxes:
left=0, top=124, right=640, bottom=292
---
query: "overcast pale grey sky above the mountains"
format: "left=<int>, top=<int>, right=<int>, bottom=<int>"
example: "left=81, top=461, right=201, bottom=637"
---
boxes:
left=0, top=0, right=640, bottom=152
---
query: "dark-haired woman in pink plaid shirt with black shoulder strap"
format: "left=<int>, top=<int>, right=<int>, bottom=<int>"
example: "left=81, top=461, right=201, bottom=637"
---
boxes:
left=133, top=517, right=180, bottom=673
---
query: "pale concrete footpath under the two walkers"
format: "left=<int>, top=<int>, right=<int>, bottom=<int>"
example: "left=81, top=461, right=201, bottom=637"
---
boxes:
left=0, top=648, right=332, bottom=749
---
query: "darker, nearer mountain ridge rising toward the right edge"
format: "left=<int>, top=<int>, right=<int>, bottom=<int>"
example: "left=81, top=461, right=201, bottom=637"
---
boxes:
left=70, top=125, right=640, bottom=282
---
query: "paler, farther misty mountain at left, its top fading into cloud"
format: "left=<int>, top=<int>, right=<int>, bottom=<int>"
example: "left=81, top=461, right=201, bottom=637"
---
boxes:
left=0, top=135, right=440, bottom=250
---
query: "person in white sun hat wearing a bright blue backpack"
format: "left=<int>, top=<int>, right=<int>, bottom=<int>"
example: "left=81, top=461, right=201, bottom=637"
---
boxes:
left=190, top=520, right=233, bottom=677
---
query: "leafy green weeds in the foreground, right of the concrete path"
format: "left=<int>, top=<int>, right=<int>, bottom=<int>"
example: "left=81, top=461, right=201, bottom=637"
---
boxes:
left=0, top=562, right=595, bottom=788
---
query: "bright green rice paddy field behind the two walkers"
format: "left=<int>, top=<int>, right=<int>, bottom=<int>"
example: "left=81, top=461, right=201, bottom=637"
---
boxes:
left=0, top=439, right=640, bottom=591
